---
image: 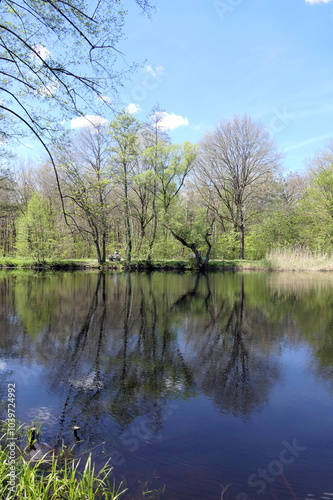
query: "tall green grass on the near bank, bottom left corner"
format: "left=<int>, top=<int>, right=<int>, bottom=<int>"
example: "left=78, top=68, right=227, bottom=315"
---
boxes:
left=0, top=421, right=126, bottom=500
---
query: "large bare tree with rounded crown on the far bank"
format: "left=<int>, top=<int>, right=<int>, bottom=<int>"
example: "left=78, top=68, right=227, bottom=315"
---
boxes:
left=196, top=116, right=281, bottom=259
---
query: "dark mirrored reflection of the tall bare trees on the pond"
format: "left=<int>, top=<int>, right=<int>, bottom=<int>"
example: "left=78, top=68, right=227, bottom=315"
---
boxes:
left=0, top=272, right=278, bottom=432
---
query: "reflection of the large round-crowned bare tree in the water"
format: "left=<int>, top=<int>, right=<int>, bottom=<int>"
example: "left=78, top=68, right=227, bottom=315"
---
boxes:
left=176, top=276, right=279, bottom=418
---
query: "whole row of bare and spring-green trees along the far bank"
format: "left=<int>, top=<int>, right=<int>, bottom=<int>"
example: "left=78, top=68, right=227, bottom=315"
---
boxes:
left=0, top=109, right=333, bottom=266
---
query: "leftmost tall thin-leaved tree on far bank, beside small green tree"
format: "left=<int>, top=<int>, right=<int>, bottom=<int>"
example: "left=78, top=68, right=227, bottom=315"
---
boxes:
left=56, top=126, right=114, bottom=264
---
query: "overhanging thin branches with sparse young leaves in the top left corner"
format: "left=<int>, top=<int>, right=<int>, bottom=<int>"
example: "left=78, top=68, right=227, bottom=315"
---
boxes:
left=0, top=0, right=150, bottom=146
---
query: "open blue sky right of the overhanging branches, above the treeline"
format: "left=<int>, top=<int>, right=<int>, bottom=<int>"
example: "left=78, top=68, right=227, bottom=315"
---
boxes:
left=110, top=0, right=333, bottom=171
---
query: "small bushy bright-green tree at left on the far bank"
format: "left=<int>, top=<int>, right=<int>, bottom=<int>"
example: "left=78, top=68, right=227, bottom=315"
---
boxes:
left=17, top=192, right=55, bottom=263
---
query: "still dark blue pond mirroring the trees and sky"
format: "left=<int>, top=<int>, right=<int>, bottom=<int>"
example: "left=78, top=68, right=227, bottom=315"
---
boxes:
left=0, top=271, right=333, bottom=500
